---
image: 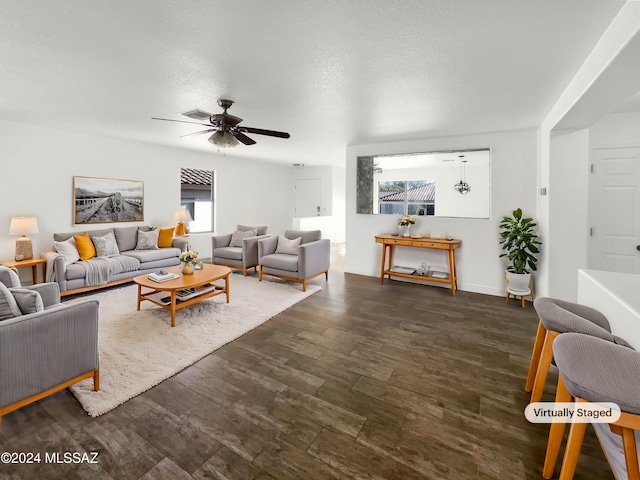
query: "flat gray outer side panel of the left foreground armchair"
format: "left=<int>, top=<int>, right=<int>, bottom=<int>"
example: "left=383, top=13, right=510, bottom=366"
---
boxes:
left=0, top=300, right=99, bottom=406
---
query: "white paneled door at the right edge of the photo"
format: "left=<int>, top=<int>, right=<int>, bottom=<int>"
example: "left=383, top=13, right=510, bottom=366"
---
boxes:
left=589, top=147, right=640, bottom=274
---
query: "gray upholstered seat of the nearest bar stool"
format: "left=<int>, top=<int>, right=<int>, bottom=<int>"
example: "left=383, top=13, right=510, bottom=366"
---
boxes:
left=553, top=333, right=640, bottom=413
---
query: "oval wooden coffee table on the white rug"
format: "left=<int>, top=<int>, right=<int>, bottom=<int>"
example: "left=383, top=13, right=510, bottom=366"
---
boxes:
left=133, top=265, right=231, bottom=327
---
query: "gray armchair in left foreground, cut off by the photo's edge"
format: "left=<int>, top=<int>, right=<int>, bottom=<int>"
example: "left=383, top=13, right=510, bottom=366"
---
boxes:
left=0, top=266, right=100, bottom=421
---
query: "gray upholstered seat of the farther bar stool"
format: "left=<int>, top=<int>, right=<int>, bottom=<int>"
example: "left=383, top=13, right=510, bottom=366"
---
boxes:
left=533, top=297, right=614, bottom=342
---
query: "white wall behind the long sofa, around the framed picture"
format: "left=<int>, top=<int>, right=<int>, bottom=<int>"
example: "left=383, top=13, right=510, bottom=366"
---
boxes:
left=0, top=122, right=293, bottom=259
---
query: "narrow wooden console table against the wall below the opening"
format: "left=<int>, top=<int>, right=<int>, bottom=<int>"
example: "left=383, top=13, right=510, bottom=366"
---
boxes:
left=376, top=235, right=462, bottom=296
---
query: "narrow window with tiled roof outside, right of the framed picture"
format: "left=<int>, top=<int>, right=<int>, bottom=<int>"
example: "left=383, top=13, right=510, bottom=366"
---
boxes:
left=180, top=168, right=215, bottom=233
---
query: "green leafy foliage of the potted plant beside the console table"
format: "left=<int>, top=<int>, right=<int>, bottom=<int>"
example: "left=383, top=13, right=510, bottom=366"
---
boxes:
left=500, top=208, right=542, bottom=274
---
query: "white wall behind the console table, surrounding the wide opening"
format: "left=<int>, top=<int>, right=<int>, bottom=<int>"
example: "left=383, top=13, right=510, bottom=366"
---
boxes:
left=345, top=130, right=537, bottom=295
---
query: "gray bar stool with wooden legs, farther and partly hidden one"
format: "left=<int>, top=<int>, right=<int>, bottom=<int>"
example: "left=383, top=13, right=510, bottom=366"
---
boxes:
left=524, top=297, right=629, bottom=402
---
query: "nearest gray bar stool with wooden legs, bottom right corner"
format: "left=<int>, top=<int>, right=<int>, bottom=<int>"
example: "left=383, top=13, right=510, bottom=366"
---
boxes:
left=542, top=333, right=640, bottom=480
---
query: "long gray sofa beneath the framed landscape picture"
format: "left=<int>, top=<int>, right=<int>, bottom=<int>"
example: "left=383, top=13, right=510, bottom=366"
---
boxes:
left=41, top=226, right=188, bottom=296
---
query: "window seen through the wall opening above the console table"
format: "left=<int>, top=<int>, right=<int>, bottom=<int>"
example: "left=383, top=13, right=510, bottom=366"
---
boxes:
left=378, top=180, right=436, bottom=215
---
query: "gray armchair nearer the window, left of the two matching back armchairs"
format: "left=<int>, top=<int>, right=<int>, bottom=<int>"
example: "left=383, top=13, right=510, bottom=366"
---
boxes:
left=211, top=225, right=269, bottom=277
